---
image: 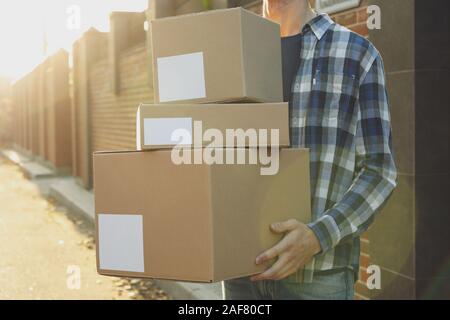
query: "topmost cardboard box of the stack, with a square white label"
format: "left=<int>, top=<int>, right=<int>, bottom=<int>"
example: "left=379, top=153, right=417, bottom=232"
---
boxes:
left=150, top=8, right=283, bottom=103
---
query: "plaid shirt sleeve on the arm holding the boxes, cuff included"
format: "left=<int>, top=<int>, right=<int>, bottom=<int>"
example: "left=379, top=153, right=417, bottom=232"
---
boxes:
left=308, top=54, right=397, bottom=253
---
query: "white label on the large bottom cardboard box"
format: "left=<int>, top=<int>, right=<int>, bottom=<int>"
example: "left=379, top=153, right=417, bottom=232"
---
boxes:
left=98, top=214, right=144, bottom=272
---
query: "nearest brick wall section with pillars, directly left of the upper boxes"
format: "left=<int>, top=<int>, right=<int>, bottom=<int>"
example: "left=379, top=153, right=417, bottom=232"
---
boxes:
left=72, top=12, right=148, bottom=189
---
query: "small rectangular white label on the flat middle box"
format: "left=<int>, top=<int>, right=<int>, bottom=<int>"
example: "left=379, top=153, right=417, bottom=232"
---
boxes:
left=144, top=118, right=192, bottom=146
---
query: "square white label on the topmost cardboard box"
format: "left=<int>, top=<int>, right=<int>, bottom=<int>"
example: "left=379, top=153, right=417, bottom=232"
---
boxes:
left=157, top=52, right=206, bottom=102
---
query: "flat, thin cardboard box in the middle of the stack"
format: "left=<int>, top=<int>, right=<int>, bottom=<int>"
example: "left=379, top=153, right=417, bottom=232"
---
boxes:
left=136, top=103, right=289, bottom=150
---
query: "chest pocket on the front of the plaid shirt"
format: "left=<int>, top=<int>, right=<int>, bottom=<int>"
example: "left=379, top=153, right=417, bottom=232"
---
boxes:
left=311, top=70, right=358, bottom=127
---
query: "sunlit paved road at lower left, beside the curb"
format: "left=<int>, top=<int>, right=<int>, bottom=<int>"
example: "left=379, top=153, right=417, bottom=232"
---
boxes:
left=0, top=157, right=167, bottom=299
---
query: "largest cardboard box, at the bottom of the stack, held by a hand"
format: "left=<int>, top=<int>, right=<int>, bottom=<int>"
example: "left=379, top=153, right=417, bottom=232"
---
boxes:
left=94, top=148, right=310, bottom=282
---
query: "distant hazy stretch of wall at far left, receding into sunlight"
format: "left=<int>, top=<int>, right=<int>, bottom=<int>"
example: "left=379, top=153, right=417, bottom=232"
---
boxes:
left=12, top=50, right=71, bottom=173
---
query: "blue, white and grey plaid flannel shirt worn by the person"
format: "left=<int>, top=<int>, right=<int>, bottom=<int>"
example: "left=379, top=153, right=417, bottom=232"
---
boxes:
left=290, top=14, right=397, bottom=282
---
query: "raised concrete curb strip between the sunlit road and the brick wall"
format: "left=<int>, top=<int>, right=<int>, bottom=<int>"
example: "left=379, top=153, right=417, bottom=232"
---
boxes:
left=0, top=150, right=222, bottom=300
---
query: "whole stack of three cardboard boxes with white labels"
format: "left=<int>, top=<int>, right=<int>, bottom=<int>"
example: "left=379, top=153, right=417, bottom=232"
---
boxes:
left=94, top=8, right=310, bottom=282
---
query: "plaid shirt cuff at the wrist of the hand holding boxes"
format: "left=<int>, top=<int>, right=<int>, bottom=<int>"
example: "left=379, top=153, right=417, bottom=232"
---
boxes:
left=307, top=214, right=341, bottom=254
